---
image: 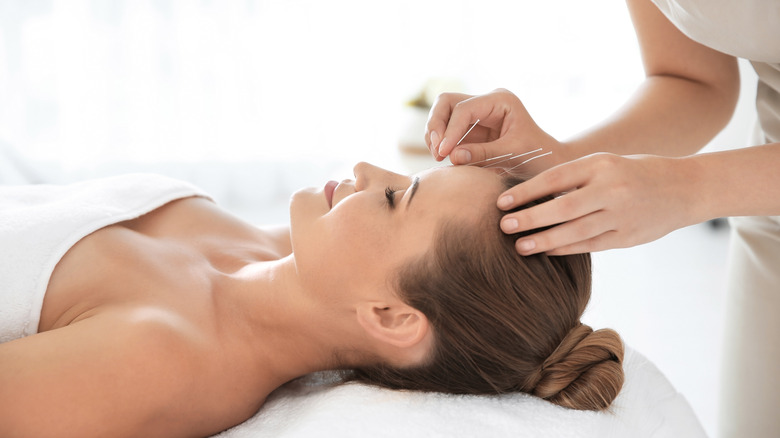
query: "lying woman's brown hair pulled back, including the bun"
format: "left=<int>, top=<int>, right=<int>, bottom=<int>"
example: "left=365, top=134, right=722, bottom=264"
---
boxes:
left=350, top=177, right=623, bottom=410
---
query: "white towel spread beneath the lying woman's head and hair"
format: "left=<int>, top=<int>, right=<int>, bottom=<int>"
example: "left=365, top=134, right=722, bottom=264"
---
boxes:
left=216, top=349, right=706, bottom=438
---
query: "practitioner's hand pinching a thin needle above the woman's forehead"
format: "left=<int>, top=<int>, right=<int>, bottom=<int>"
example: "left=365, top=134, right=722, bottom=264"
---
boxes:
left=425, top=89, right=565, bottom=173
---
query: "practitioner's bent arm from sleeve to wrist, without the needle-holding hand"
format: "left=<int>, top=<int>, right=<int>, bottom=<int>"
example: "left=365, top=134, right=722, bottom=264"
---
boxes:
left=563, top=0, right=740, bottom=159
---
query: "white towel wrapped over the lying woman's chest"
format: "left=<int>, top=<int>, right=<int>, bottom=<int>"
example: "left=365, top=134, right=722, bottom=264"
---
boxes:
left=0, top=174, right=205, bottom=342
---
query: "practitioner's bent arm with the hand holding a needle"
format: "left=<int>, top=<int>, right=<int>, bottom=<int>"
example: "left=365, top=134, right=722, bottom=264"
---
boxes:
left=425, top=0, right=740, bottom=166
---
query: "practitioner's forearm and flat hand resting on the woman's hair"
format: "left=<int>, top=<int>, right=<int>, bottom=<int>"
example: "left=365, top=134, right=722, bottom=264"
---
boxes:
left=499, top=143, right=780, bottom=255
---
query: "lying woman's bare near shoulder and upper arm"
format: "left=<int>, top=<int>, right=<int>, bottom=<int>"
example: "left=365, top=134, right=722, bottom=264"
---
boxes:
left=0, top=309, right=251, bottom=437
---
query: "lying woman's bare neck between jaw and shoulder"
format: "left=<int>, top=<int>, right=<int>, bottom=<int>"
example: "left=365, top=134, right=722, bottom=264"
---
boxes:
left=217, top=255, right=368, bottom=386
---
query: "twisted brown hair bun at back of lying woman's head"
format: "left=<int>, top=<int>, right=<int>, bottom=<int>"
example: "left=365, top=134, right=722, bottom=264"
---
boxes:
left=530, top=324, right=624, bottom=410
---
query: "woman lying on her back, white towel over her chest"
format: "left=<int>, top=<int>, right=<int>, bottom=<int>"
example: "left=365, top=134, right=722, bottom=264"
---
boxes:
left=0, top=163, right=623, bottom=438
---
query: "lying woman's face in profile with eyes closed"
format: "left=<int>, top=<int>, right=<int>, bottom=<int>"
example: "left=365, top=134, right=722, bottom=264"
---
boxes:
left=290, top=163, right=503, bottom=300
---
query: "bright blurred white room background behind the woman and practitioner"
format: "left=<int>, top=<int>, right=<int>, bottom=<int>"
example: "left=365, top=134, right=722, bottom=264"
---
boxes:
left=0, top=0, right=755, bottom=434
